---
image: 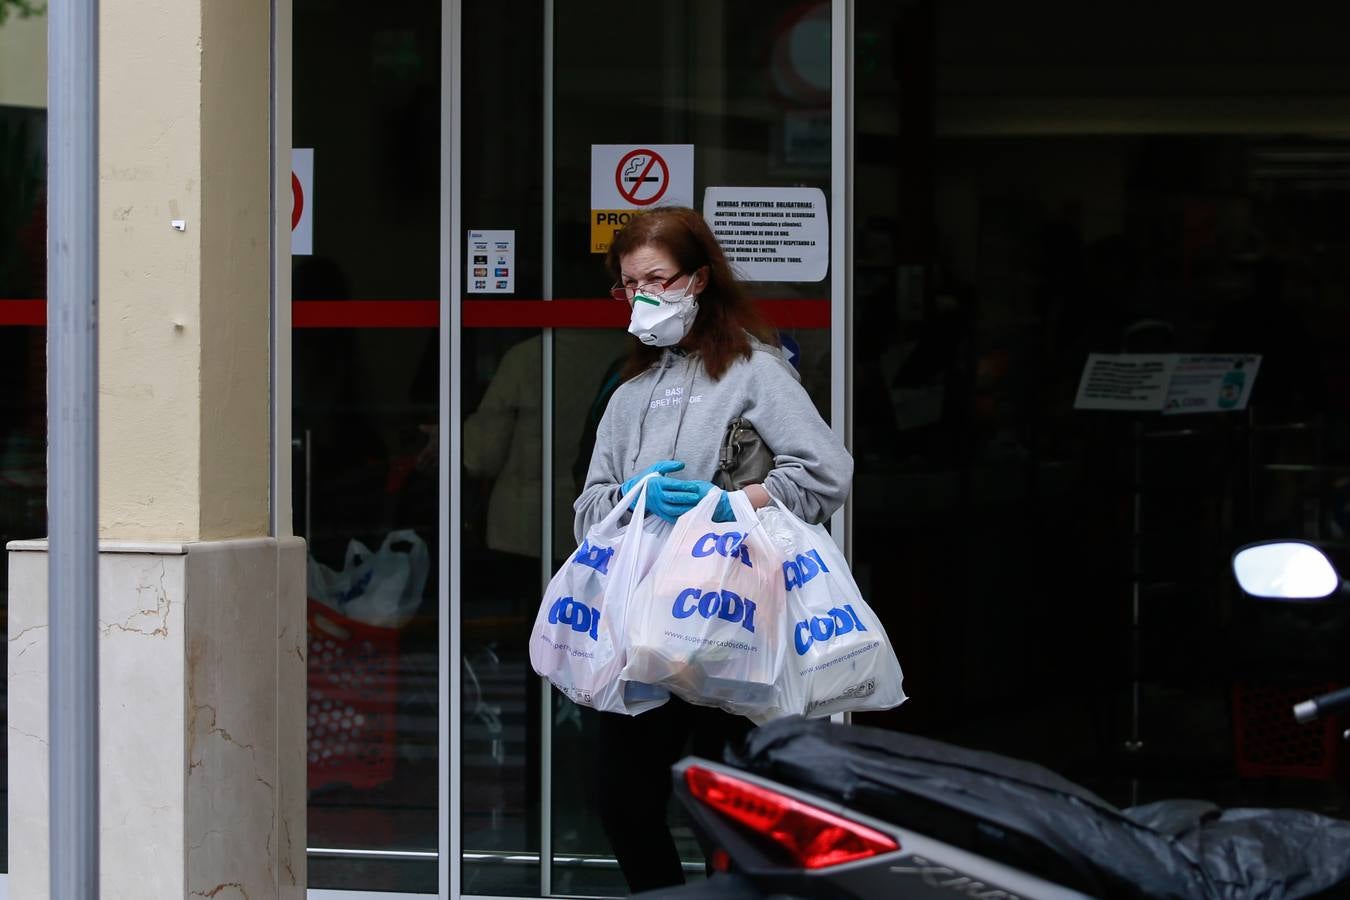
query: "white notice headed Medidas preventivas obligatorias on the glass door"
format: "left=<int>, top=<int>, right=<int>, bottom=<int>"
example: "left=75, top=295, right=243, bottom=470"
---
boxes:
left=703, top=188, right=830, bottom=282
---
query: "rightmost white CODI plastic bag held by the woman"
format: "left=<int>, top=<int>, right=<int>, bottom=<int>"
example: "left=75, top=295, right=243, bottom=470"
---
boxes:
left=752, top=499, right=905, bottom=722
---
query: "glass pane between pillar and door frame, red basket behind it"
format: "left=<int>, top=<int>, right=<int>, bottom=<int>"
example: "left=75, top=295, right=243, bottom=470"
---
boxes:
left=292, top=0, right=441, bottom=893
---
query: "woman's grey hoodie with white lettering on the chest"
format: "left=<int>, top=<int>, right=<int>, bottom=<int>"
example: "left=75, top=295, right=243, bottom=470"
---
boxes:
left=574, top=341, right=853, bottom=542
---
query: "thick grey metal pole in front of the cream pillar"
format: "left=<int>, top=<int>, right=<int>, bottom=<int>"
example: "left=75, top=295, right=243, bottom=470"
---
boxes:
left=47, top=0, right=99, bottom=899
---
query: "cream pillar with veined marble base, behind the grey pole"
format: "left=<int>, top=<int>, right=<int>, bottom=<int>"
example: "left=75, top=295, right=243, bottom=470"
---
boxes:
left=8, top=0, right=305, bottom=900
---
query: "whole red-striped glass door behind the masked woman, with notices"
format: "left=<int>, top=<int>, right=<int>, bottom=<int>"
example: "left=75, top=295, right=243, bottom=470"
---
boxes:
left=453, top=0, right=846, bottom=896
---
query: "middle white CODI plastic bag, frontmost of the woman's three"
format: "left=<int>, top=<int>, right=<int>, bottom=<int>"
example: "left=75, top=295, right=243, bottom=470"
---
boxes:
left=622, top=488, right=784, bottom=714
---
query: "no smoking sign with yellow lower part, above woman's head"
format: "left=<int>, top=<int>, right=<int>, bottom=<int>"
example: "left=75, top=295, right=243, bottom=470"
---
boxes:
left=591, top=144, right=694, bottom=254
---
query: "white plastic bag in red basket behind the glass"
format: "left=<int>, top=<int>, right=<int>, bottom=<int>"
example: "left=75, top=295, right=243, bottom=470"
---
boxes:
left=308, top=530, right=431, bottom=627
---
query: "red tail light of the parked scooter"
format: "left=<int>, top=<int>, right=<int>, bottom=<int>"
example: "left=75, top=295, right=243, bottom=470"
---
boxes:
left=684, top=765, right=900, bottom=869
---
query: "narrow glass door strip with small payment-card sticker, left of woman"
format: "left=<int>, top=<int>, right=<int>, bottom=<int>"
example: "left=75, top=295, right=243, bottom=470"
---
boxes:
left=447, top=1, right=547, bottom=896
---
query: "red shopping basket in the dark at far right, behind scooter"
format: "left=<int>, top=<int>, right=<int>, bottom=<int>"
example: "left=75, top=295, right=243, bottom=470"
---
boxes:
left=1233, top=684, right=1341, bottom=779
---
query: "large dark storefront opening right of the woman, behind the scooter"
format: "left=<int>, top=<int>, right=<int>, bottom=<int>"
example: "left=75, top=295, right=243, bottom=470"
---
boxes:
left=852, top=1, right=1350, bottom=810
